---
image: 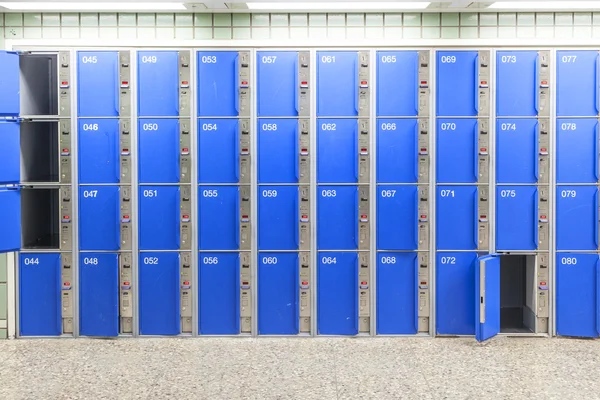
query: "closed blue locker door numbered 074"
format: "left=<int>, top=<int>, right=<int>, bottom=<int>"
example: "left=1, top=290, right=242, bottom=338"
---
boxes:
left=496, top=119, right=547, bottom=183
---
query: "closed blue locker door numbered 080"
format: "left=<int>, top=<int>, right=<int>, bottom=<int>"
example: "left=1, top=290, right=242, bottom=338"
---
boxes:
left=556, top=253, right=600, bottom=337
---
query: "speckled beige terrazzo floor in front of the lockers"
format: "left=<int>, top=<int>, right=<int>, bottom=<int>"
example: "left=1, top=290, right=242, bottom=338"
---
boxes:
left=0, top=337, right=600, bottom=400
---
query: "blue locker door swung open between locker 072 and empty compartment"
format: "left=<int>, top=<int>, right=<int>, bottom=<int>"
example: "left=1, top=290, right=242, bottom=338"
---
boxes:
left=475, top=254, right=500, bottom=342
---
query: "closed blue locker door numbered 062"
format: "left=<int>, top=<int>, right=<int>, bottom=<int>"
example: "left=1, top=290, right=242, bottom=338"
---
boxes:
left=317, top=118, right=358, bottom=183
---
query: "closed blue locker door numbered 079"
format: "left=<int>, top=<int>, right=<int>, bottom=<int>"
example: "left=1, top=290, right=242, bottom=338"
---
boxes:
left=556, top=186, right=598, bottom=250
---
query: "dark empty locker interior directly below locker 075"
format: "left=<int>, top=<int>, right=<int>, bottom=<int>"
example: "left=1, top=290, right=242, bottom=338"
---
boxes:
left=500, top=255, right=536, bottom=333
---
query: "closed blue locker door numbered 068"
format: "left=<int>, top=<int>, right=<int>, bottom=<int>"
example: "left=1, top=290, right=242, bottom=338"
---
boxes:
left=377, top=253, right=419, bottom=335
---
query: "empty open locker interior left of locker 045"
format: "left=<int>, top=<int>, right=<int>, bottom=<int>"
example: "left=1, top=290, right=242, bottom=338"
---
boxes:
left=19, top=53, right=59, bottom=116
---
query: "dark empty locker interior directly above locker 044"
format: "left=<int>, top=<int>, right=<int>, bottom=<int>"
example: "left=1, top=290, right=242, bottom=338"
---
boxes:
left=21, top=188, right=60, bottom=249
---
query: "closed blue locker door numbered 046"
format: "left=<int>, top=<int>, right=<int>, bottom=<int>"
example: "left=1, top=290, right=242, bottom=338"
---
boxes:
left=78, top=119, right=119, bottom=183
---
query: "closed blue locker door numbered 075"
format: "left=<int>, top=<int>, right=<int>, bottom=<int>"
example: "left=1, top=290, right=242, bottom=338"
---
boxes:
left=496, top=186, right=548, bottom=250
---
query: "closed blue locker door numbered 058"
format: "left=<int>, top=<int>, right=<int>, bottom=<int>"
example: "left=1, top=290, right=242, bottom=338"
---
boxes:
left=258, top=118, right=299, bottom=183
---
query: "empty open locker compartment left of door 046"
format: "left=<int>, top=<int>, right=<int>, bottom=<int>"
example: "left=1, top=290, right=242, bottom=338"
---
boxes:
left=21, top=121, right=60, bottom=182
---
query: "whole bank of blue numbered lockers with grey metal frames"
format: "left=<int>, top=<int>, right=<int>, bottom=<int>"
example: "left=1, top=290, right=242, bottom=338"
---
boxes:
left=0, top=43, right=600, bottom=341
